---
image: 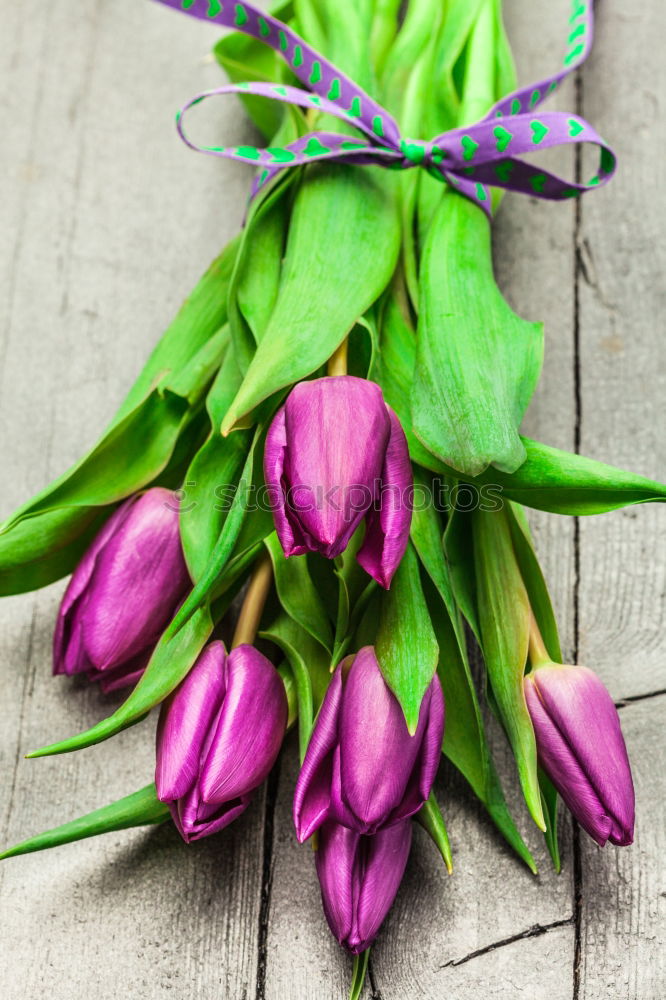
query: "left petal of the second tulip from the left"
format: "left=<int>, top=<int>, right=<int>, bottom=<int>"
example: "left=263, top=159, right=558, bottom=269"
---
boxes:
left=155, top=641, right=226, bottom=802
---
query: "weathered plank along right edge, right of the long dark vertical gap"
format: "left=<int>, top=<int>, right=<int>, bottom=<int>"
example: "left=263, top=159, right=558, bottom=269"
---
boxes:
left=578, top=2, right=666, bottom=1000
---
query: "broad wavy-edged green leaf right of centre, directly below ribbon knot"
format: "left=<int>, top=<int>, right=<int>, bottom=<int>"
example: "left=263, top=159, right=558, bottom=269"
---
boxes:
left=411, top=191, right=543, bottom=476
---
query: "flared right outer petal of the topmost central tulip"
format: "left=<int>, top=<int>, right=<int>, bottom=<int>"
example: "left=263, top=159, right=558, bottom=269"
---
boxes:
left=356, top=407, right=413, bottom=590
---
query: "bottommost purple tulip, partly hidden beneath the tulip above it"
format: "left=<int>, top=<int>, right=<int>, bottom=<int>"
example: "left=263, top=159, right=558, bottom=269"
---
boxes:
left=315, top=820, right=412, bottom=955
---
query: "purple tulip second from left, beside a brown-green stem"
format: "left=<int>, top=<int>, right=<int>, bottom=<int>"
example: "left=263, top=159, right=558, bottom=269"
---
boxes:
left=155, top=641, right=287, bottom=843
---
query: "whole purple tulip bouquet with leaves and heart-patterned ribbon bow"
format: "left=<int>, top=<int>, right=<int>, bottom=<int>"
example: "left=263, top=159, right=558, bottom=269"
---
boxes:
left=0, top=0, right=666, bottom=995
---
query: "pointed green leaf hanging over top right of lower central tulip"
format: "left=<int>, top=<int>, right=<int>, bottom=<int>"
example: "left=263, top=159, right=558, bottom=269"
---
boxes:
left=375, top=543, right=439, bottom=735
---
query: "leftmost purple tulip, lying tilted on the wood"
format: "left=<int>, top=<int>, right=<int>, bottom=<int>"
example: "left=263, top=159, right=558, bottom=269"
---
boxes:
left=53, top=487, right=191, bottom=691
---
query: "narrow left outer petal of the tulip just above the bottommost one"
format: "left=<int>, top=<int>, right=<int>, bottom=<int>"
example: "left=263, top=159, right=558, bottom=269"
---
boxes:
left=293, top=664, right=342, bottom=844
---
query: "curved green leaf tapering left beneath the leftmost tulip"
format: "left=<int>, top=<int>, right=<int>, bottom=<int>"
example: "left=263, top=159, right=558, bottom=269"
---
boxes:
left=26, top=607, right=213, bottom=757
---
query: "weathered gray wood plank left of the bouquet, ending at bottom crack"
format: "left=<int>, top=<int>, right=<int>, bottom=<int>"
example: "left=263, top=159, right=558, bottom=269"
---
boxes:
left=0, top=0, right=263, bottom=1000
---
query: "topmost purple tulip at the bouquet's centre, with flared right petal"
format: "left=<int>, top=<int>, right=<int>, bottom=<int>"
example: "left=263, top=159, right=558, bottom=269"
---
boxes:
left=264, top=375, right=412, bottom=588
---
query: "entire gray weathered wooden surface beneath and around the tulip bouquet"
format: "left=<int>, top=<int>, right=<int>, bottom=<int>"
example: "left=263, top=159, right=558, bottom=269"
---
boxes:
left=0, top=0, right=666, bottom=1000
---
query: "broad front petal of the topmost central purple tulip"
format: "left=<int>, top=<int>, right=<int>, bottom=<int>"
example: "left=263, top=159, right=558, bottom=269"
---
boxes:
left=276, top=375, right=391, bottom=559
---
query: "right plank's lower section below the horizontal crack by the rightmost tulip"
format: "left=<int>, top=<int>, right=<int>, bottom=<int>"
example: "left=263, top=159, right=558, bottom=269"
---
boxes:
left=579, top=696, right=666, bottom=1000
